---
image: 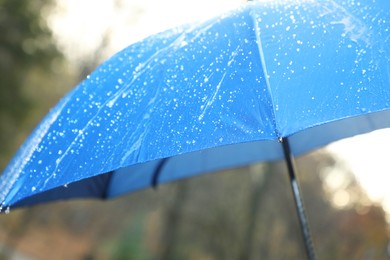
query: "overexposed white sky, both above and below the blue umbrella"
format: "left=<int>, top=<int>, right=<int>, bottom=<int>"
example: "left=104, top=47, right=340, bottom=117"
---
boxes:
left=48, top=0, right=390, bottom=212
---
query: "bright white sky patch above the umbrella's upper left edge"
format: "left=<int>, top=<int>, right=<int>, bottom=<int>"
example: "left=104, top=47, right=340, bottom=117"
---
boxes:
left=49, top=0, right=245, bottom=59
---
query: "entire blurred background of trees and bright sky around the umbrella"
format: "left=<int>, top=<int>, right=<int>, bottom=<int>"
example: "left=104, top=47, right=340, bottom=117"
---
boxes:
left=0, top=0, right=390, bottom=259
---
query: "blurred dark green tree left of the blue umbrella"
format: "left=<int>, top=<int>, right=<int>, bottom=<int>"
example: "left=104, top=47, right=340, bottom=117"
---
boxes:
left=0, top=0, right=61, bottom=168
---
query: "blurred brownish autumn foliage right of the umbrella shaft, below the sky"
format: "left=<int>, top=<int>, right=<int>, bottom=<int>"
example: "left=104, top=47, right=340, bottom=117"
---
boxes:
left=299, top=153, right=389, bottom=259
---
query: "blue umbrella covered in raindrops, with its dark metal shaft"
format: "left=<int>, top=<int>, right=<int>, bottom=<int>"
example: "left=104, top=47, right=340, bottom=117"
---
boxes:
left=0, top=0, right=390, bottom=255
